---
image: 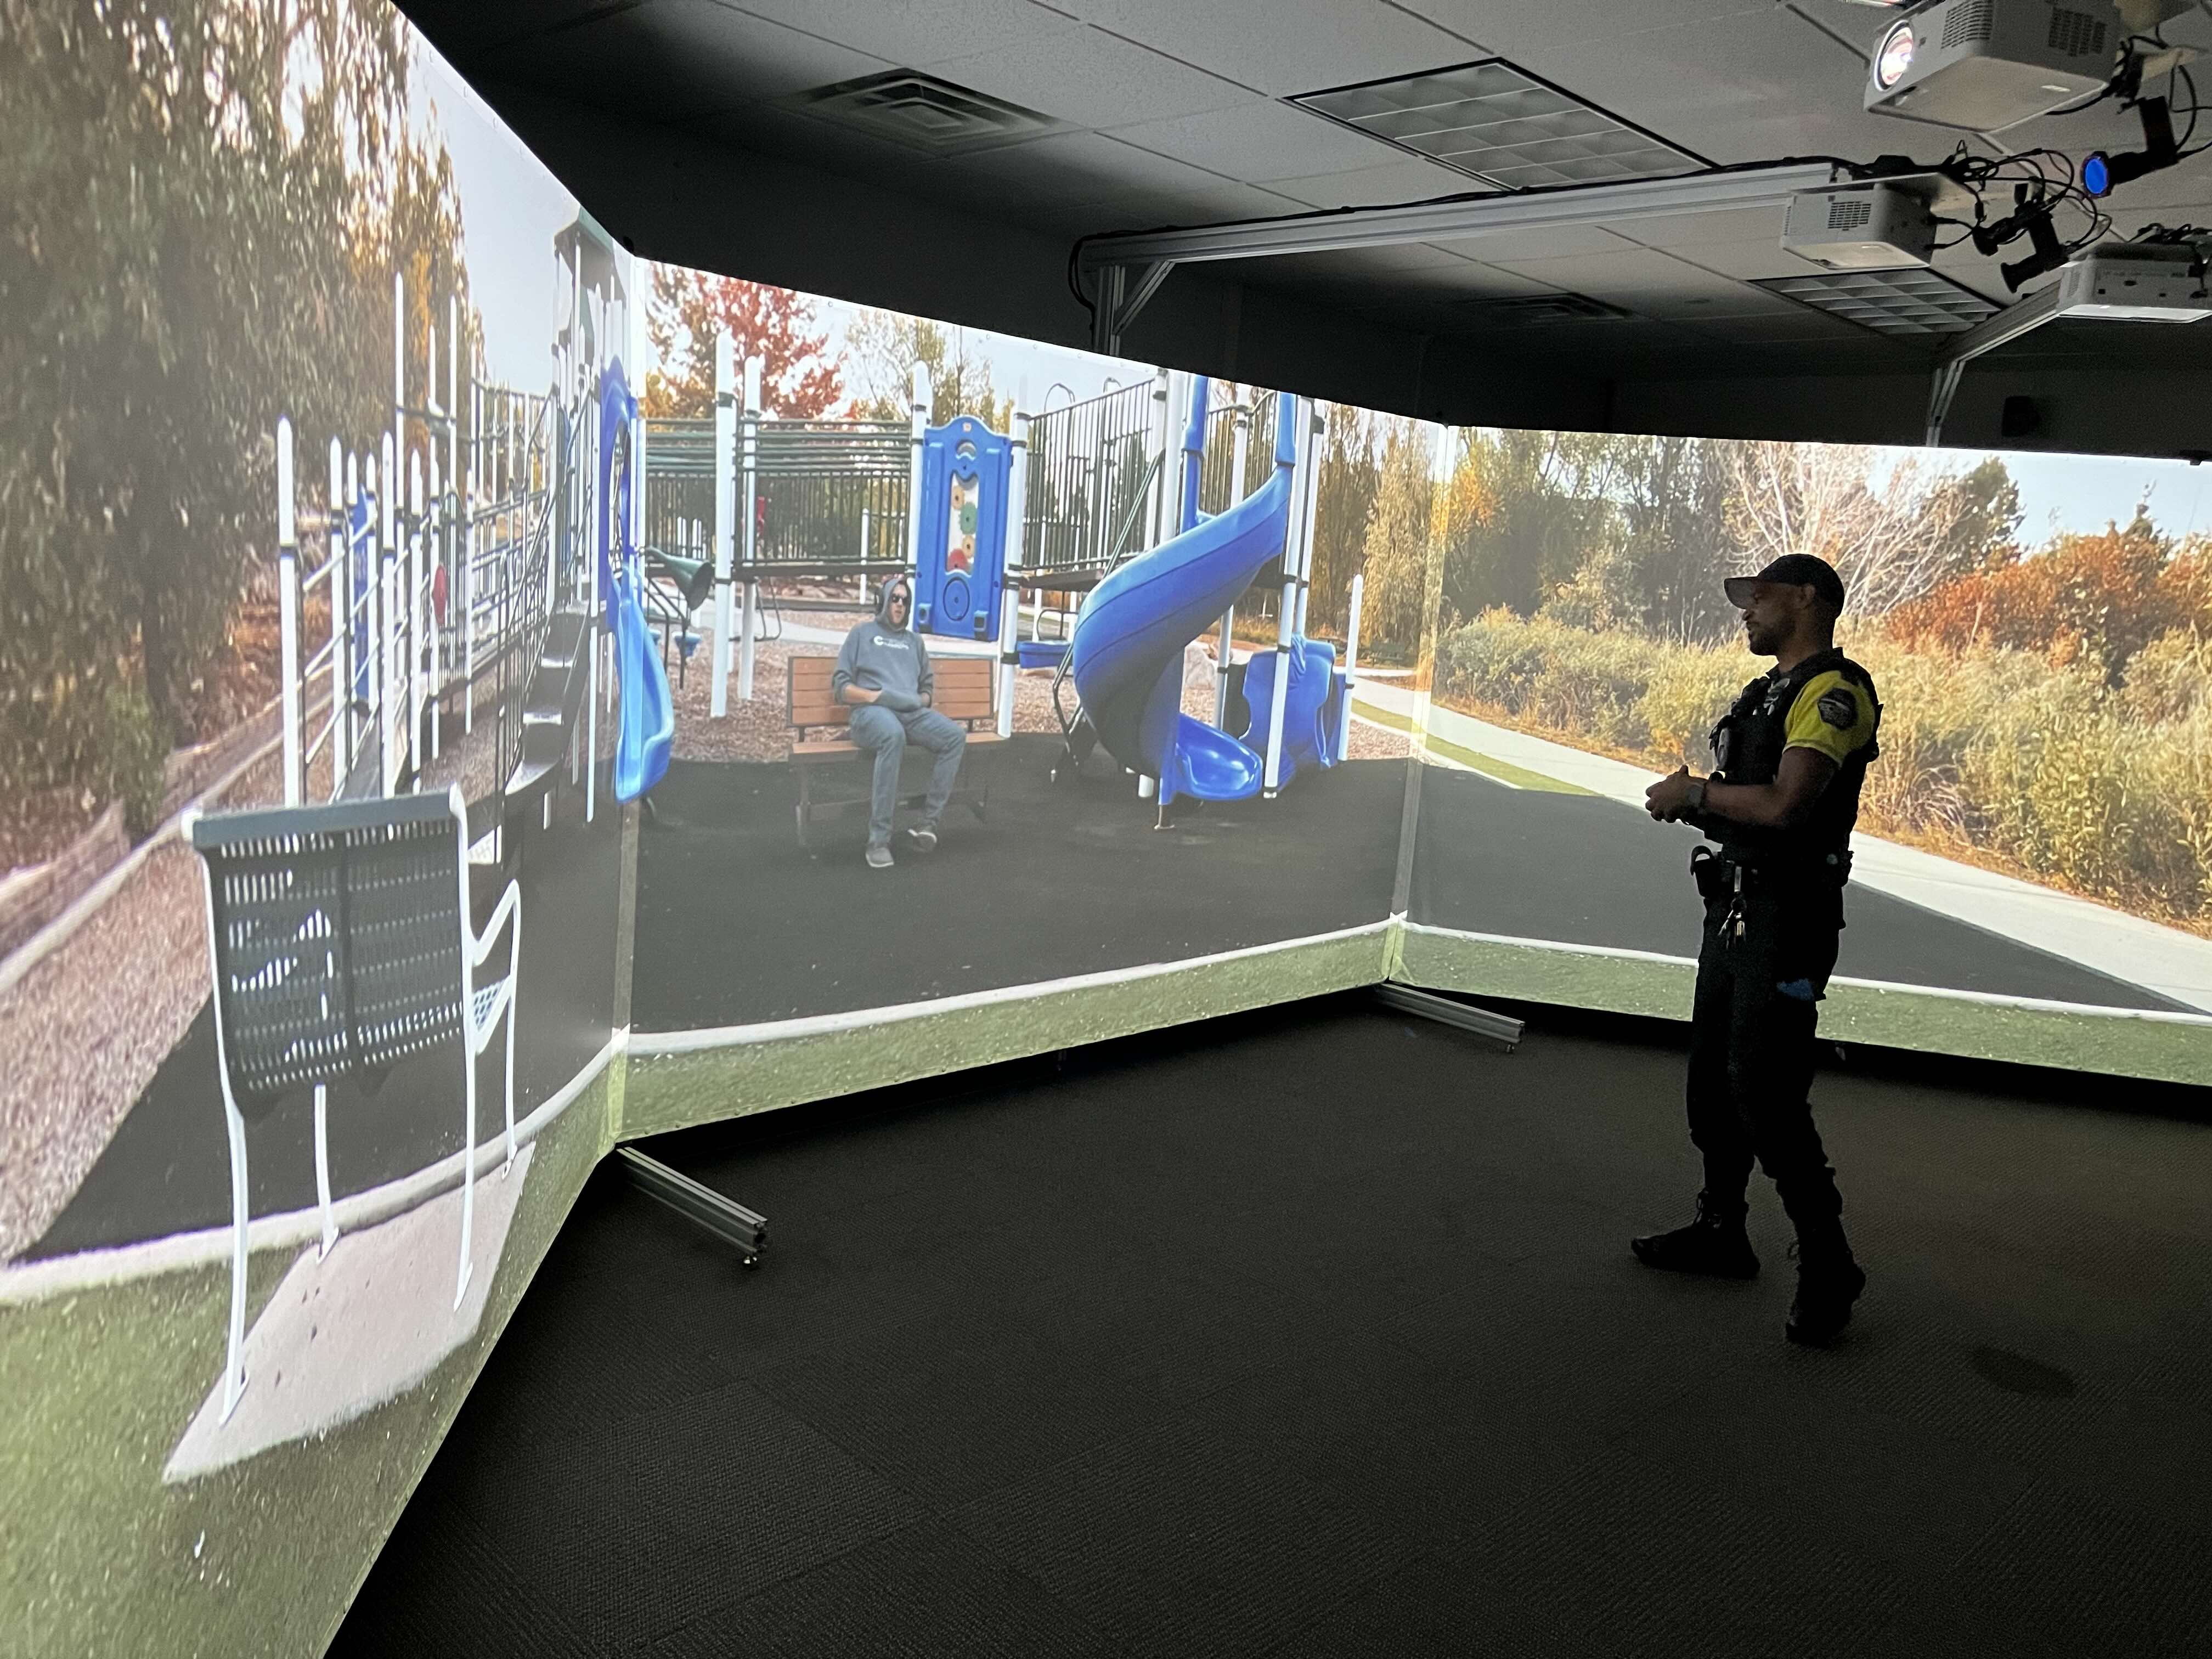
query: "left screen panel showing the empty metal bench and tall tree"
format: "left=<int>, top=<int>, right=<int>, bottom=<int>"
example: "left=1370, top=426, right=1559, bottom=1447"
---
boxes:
left=0, top=19, right=644, bottom=1652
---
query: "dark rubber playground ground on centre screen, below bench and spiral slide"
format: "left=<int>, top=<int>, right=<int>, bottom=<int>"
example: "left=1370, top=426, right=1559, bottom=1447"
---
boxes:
left=630, top=735, right=1404, bottom=1033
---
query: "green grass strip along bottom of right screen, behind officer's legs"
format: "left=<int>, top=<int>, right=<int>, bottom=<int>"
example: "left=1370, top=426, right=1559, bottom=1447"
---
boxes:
left=1391, top=929, right=2212, bottom=1084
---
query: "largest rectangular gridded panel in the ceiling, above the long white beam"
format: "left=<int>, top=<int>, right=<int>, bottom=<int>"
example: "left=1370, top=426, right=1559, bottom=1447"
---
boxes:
left=1292, top=58, right=1706, bottom=190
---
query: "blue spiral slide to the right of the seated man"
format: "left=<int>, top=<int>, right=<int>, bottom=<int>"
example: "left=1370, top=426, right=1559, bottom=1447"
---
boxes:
left=1068, top=381, right=1299, bottom=805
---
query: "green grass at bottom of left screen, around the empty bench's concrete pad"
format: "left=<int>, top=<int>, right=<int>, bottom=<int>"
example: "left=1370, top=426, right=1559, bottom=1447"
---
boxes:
left=0, top=1068, right=611, bottom=1659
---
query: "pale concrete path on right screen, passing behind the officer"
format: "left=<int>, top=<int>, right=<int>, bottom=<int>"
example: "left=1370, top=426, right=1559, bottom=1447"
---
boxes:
left=1354, top=679, right=2212, bottom=1013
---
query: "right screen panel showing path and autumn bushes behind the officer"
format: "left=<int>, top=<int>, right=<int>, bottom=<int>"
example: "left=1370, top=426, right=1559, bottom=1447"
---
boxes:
left=1389, top=431, right=2212, bottom=1082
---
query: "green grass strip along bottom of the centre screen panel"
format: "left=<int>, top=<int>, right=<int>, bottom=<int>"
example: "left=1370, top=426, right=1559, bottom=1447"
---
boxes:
left=622, top=927, right=1387, bottom=1139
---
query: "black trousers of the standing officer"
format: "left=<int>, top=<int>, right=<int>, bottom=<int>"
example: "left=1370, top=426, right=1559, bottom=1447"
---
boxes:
left=1688, top=867, right=1847, bottom=1254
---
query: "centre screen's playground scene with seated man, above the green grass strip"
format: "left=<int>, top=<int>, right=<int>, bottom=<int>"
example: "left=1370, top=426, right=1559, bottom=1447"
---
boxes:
left=633, top=272, right=1409, bottom=1035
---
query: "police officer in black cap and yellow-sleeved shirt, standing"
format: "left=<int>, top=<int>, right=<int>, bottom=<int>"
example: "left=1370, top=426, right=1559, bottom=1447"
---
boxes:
left=1630, top=553, right=1882, bottom=1342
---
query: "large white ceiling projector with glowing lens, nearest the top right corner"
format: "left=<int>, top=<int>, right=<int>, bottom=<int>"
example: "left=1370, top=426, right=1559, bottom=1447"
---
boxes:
left=1865, top=0, right=2128, bottom=133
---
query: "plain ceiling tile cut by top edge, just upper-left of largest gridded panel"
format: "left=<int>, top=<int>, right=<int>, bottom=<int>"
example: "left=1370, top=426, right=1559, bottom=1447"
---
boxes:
left=1035, top=0, right=1482, bottom=97
